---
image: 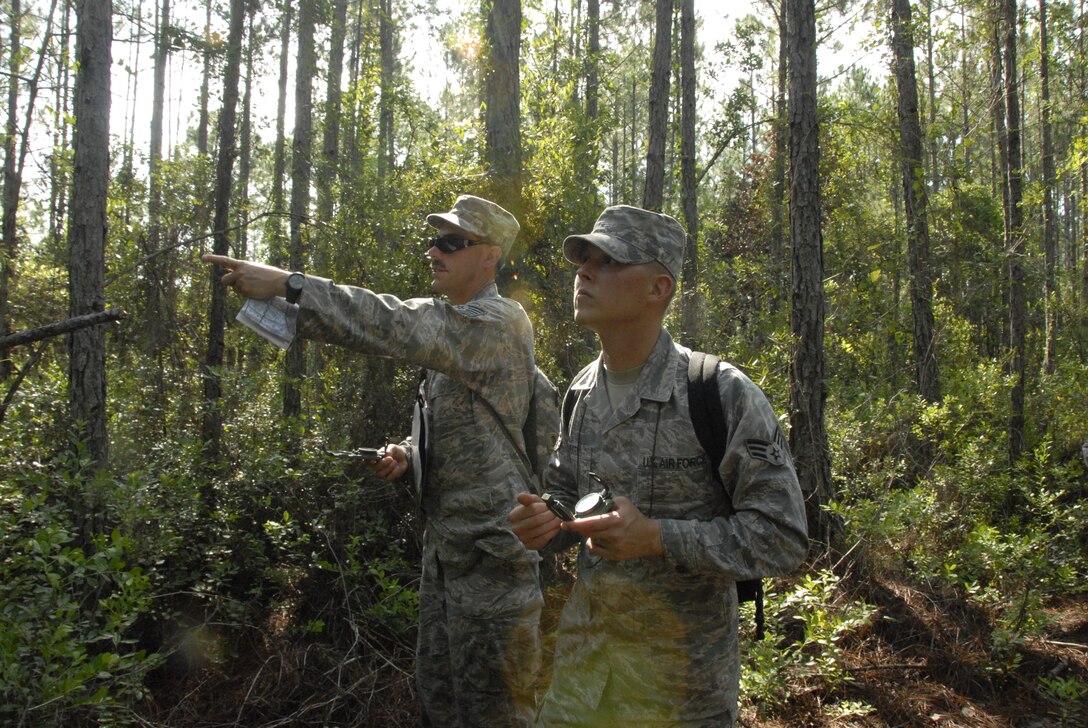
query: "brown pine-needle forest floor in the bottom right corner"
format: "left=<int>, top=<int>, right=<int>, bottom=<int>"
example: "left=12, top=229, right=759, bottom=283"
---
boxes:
left=757, top=579, right=1088, bottom=728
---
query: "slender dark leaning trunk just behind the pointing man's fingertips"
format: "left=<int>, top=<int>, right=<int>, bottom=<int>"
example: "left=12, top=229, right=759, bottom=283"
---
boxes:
left=201, top=0, right=246, bottom=465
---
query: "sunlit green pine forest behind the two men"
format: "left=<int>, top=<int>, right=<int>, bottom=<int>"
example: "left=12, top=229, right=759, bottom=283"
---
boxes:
left=0, top=0, right=1088, bottom=725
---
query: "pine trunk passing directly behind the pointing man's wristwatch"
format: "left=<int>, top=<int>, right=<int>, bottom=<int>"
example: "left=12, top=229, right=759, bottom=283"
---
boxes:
left=283, top=2, right=317, bottom=419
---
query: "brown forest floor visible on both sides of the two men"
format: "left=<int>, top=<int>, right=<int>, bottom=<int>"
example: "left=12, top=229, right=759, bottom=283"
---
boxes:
left=140, top=578, right=1088, bottom=728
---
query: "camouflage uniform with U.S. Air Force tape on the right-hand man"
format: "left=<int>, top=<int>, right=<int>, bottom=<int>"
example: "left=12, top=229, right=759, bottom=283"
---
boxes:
left=539, top=329, right=807, bottom=726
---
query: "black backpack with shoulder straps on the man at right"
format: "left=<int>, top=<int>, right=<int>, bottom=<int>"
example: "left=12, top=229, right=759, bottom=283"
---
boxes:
left=562, top=351, right=764, bottom=640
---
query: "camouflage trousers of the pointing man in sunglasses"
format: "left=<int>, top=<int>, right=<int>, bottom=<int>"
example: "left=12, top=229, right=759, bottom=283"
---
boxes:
left=416, top=539, right=543, bottom=728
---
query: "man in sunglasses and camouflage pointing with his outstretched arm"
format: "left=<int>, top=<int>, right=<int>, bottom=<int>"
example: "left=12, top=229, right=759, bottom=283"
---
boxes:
left=205, top=195, right=543, bottom=728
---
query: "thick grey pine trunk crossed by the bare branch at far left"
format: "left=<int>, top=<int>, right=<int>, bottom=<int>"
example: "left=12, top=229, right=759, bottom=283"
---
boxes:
left=69, top=0, right=113, bottom=469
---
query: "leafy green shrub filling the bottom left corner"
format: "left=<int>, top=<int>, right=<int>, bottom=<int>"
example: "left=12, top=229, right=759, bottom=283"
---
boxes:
left=0, top=457, right=161, bottom=726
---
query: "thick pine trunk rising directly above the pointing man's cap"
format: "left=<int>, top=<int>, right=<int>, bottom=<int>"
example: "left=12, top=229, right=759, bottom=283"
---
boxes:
left=484, top=0, right=522, bottom=217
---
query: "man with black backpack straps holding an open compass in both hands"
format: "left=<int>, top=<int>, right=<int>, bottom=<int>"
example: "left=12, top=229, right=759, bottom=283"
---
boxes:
left=510, top=206, right=807, bottom=727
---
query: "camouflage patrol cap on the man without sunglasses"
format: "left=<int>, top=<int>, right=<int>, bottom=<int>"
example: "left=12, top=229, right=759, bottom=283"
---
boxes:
left=562, top=205, right=688, bottom=281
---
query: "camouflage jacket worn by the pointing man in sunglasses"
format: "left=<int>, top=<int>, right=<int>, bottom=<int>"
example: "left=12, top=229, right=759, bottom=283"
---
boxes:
left=296, top=275, right=536, bottom=568
